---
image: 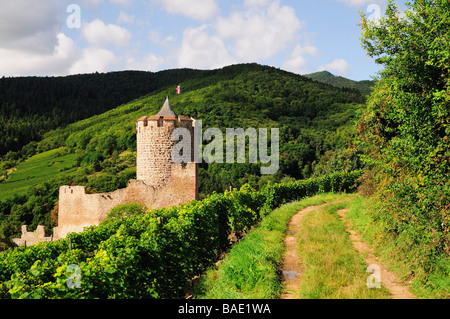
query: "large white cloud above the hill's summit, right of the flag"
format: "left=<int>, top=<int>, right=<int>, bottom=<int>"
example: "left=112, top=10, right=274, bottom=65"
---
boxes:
left=216, top=0, right=301, bottom=62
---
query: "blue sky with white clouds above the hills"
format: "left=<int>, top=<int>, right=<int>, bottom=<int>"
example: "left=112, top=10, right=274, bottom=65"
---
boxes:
left=0, top=0, right=404, bottom=80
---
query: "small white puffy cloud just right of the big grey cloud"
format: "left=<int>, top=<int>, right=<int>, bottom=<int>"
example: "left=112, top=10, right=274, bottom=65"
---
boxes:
left=82, top=19, right=132, bottom=47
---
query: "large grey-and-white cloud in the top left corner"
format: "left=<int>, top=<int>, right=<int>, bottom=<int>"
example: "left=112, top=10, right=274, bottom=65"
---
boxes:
left=0, top=0, right=81, bottom=76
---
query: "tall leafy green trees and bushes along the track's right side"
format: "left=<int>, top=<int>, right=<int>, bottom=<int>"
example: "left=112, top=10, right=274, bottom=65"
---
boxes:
left=359, top=0, right=450, bottom=288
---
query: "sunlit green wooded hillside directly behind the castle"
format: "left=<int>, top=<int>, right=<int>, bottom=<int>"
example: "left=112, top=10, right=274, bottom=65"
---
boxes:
left=0, top=64, right=364, bottom=246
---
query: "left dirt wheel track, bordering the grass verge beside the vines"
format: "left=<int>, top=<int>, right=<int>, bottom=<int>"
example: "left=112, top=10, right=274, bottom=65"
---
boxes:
left=280, top=206, right=320, bottom=299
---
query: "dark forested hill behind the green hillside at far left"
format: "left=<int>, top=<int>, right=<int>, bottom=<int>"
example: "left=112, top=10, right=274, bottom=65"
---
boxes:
left=0, top=69, right=209, bottom=157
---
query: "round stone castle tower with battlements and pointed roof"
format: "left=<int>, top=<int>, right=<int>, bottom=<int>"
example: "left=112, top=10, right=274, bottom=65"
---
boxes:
left=136, top=98, right=194, bottom=188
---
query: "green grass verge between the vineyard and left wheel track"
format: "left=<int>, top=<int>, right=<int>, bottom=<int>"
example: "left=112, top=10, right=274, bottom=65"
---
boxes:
left=193, top=194, right=348, bottom=299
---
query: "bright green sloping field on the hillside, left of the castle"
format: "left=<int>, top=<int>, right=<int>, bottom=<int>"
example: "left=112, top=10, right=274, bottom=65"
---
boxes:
left=0, top=147, right=78, bottom=200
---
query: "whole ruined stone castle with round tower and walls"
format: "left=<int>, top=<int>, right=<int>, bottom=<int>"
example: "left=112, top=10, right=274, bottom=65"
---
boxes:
left=13, top=98, right=198, bottom=246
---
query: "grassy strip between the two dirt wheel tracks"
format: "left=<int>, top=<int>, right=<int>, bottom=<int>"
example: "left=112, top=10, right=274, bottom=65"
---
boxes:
left=298, top=202, right=389, bottom=299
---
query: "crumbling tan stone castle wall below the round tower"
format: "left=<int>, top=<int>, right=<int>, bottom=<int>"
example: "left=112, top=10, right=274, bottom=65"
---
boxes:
left=53, top=163, right=198, bottom=239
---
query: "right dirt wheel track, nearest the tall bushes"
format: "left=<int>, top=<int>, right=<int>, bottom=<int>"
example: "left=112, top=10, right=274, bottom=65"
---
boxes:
left=338, top=209, right=416, bottom=299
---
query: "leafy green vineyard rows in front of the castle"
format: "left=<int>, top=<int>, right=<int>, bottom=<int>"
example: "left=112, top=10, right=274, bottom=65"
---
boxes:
left=0, top=171, right=362, bottom=299
